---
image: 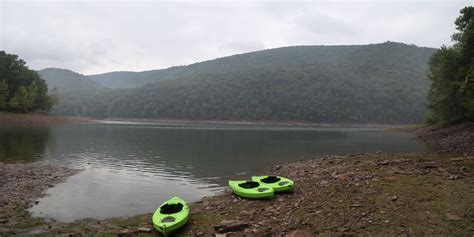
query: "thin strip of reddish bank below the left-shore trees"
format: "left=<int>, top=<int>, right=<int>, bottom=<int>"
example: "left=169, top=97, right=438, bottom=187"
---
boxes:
left=0, top=112, right=92, bottom=127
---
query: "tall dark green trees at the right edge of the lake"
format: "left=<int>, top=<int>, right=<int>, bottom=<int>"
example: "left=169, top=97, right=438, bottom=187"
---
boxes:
left=427, top=7, right=474, bottom=123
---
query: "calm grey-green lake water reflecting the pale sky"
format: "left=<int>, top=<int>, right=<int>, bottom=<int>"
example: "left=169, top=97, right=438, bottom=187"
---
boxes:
left=0, top=123, right=427, bottom=221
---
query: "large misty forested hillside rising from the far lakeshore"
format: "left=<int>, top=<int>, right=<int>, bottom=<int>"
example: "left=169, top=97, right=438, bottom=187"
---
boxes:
left=50, top=42, right=435, bottom=123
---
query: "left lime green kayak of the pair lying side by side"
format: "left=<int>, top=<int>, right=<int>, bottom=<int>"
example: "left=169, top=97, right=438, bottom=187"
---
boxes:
left=229, top=180, right=274, bottom=199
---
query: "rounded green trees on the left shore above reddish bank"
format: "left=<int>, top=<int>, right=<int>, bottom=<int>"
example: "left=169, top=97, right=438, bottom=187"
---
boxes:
left=0, top=51, right=56, bottom=112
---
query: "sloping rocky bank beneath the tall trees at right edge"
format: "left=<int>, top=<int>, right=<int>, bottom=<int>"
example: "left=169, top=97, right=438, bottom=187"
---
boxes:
left=412, top=123, right=474, bottom=155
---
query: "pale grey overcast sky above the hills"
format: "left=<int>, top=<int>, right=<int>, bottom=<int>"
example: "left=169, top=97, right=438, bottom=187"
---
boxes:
left=0, top=0, right=472, bottom=74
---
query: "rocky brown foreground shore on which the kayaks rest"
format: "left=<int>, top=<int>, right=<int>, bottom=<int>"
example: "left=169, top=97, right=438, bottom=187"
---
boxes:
left=0, top=154, right=474, bottom=236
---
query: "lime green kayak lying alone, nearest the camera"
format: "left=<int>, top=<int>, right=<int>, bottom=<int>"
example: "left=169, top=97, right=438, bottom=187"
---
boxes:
left=152, top=197, right=189, bottom=236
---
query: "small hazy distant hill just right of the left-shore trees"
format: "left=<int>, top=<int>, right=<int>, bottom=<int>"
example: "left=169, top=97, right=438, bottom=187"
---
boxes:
left=38, top=68, right=101, bottom=91
